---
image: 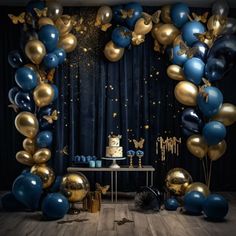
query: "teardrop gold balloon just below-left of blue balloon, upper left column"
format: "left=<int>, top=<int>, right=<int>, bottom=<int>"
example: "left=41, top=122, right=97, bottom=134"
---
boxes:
left=25, top=39, right=46, bottom=65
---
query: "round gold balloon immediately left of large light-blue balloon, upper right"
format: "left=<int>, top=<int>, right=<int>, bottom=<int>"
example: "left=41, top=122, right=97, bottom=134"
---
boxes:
left=156, top=24, right=180, bottom=45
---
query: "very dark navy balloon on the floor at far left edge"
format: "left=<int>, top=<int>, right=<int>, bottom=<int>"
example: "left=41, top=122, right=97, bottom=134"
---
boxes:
left=1, top=192, right=25, bottom=211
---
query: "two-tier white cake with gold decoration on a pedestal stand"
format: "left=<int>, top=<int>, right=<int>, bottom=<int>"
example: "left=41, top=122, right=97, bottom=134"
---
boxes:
left=106, top=135, right=123, bottom=157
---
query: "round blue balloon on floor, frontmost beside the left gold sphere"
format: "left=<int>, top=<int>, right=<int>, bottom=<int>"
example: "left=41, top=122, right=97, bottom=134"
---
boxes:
left=42, top=193, right=69, bottom=220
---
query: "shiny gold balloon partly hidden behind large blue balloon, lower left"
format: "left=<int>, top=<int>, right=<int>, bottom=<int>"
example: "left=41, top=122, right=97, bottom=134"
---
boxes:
left=30, top=164, right=55, bottom=189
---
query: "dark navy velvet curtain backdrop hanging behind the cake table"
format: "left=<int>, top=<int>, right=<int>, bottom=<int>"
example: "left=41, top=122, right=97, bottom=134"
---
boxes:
left=0, top=7, right=236, bottom=191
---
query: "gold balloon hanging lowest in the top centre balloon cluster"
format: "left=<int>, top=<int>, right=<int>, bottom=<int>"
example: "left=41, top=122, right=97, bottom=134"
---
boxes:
left=104, top=41, right=125, bottom=62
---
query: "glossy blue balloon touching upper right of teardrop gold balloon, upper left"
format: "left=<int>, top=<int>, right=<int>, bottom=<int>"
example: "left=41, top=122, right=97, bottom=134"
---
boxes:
left=38, top=25, right=59, bottom=52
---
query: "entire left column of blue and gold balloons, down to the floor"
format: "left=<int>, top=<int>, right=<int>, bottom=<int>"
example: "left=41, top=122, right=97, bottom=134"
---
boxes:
left=2, top=0, right=89, bottom=219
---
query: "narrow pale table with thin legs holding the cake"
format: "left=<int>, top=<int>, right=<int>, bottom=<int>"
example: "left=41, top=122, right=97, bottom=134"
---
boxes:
left=67, top=166, right=155, bottom=202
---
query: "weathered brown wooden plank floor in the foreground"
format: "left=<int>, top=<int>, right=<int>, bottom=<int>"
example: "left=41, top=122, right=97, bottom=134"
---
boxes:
left=0, top=193, right=236, bottom=236
